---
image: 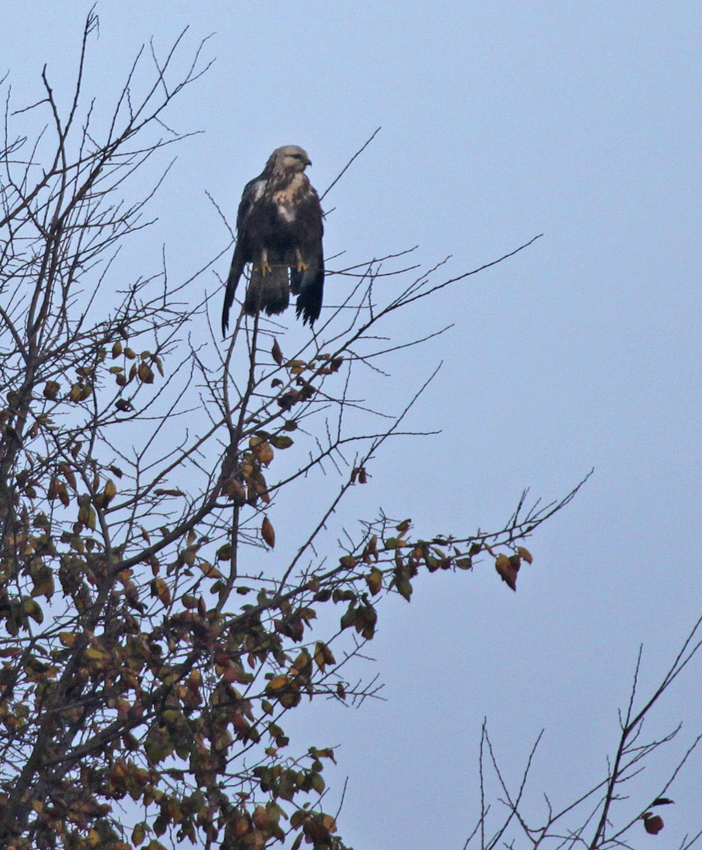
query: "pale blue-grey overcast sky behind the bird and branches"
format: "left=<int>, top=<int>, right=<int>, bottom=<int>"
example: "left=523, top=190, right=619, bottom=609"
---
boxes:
left=5, top=0, right=702, bottom=850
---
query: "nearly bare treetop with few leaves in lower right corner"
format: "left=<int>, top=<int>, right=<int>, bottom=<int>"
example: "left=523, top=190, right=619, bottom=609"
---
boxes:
left=464, top=617, right=702, bottom=850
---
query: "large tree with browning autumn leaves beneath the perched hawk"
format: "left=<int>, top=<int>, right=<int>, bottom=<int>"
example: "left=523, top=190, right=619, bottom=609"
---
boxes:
left=0, top=14, right=578, bottom=850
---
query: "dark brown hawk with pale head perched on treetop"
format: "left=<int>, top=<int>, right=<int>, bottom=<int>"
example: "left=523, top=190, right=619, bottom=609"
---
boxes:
left=222, top=145, right=324, bottom=335
